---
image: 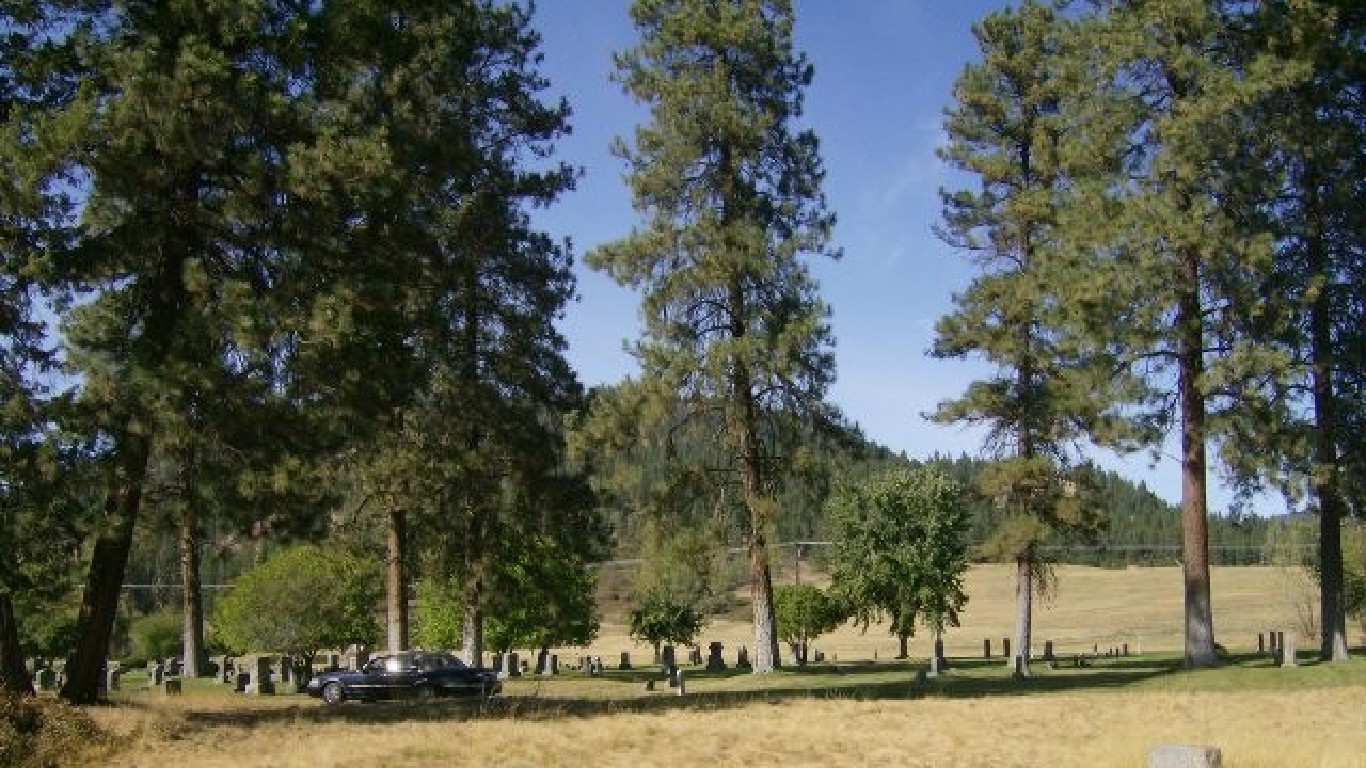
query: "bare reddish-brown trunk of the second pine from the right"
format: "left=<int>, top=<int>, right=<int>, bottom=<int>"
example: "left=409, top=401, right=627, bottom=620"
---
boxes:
left=1176, top=253, right=1218, bottom=668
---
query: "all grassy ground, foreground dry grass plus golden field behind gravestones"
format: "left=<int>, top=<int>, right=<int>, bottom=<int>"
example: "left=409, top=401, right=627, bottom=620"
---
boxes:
left=26, top=566, right=1366, bottom=768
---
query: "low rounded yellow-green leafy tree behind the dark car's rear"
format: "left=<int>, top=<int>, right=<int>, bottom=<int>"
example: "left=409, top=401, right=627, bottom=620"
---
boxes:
left=213, top=544, right=382, bottom=660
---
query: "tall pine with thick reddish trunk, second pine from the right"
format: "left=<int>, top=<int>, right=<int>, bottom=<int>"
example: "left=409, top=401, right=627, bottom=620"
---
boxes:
left=1065, top=0, right=1294, bottom=667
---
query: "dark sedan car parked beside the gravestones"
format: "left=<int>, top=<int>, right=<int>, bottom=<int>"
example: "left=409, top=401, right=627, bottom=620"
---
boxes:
left=307, top=650, right=503, bottom=704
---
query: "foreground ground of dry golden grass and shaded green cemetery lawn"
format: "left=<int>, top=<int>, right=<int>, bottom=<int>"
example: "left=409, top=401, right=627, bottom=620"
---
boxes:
left=74, top=645, right=1366, bottom=768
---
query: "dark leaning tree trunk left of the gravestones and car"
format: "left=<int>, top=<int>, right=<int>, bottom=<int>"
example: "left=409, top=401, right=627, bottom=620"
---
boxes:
left=61, top=435, right=150, bottom=705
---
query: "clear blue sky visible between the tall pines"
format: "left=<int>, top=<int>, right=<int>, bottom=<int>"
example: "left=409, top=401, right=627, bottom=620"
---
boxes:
left=521, top=0, right=1270, bottom=511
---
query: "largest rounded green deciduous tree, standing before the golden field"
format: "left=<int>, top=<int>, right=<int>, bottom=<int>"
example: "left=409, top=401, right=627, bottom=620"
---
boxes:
left=828, top=466, right=968, bottom=657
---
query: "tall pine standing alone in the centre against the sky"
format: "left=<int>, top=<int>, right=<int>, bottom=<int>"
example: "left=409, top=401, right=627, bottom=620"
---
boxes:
left=587, top=0, right=835, bottom=672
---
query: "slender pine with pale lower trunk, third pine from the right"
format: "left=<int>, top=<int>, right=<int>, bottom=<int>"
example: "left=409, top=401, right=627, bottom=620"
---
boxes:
left=934, top=1, right=1127, bottom=675
